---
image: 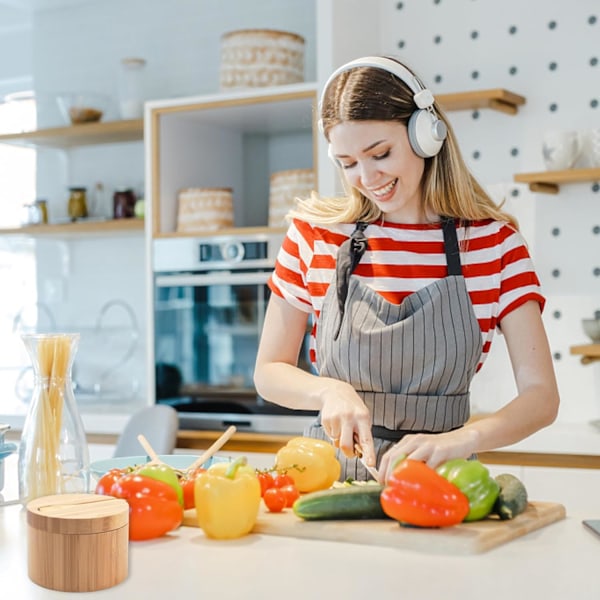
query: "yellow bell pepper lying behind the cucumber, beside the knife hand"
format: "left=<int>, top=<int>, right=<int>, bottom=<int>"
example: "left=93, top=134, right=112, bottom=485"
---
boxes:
left=275, top=437, right=341, bottom=493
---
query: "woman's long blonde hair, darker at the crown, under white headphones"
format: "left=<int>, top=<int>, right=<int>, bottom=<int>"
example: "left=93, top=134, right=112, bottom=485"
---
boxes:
left=289, top=61, right=518, bottom=229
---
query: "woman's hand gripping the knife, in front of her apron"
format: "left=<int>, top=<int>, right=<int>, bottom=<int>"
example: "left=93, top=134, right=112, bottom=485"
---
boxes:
left=321, top=379, right=375, bottom=466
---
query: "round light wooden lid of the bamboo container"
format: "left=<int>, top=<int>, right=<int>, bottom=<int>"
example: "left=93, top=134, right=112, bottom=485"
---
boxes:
left=27, top=494, right=129, bottom=535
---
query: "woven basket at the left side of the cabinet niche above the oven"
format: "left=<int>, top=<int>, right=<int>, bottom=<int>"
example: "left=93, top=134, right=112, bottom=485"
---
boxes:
left=177, top=188, right=233, bottom=232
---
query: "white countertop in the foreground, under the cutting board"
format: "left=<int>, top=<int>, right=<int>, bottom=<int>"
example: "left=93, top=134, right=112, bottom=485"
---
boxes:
left=0, top=457, right=600, bottom=600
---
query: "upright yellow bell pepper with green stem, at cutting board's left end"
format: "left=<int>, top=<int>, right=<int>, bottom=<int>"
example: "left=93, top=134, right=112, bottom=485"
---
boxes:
left=194, top=457, right=261, bottom=540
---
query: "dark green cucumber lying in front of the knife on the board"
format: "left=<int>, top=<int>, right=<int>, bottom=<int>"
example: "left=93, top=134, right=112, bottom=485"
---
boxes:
left=292, top=485, right=389, bottom=521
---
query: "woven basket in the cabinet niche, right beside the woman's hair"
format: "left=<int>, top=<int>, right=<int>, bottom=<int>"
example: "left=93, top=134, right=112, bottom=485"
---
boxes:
left=269, top=169, right=315, bottom=227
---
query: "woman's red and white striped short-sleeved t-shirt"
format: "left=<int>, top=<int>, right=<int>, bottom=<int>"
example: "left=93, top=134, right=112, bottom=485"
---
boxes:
left=269, top=219, right=545, bottom=369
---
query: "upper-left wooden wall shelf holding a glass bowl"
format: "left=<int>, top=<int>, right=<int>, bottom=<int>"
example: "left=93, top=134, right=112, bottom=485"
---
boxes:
left=0, top=119, right=144, bottom=150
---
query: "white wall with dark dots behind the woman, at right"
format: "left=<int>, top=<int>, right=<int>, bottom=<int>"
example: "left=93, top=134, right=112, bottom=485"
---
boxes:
left=379, top=0, right=600, bottom=422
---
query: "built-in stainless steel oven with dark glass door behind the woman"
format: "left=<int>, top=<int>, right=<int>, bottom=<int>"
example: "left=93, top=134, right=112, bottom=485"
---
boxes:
left=153, top=234, right=316, bottom=433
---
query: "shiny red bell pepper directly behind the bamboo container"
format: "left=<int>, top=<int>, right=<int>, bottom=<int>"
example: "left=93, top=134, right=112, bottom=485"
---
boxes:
left=103, top=474, right=183, bottom=541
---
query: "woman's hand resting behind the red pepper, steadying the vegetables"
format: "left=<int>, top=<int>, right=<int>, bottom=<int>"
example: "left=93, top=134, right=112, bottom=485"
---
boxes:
left=379, top=427, right=479, bottom=483
